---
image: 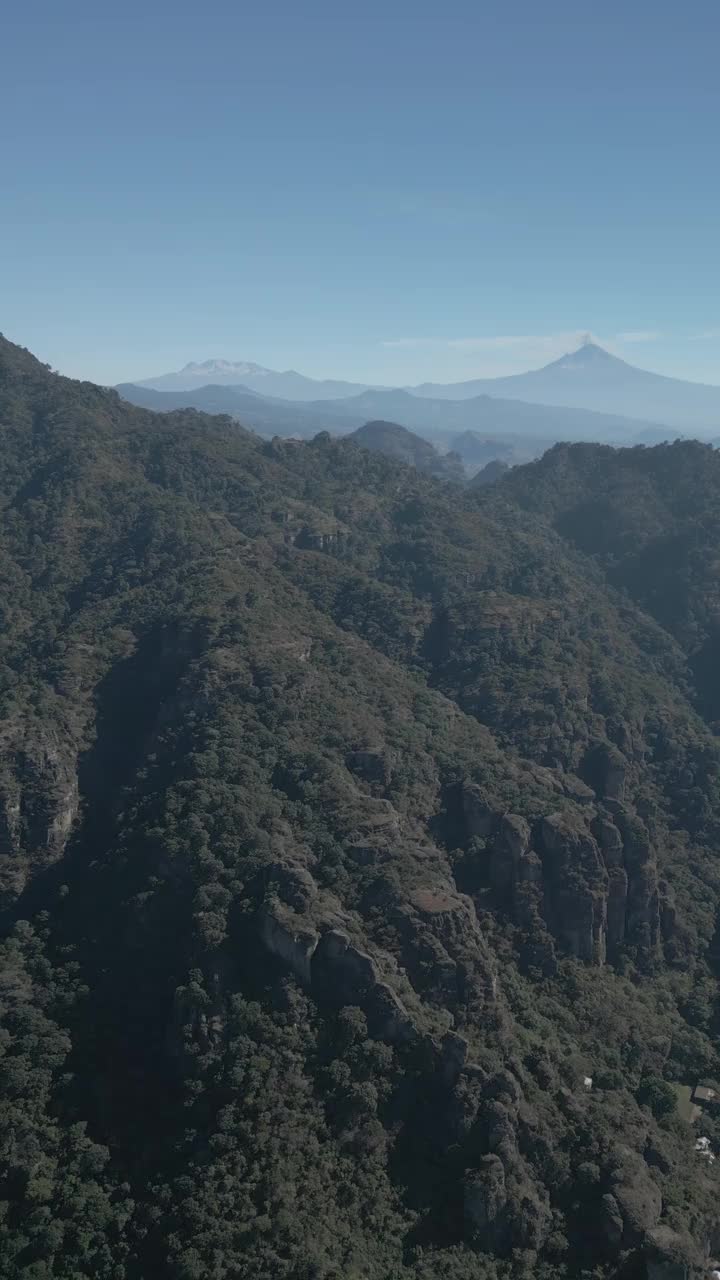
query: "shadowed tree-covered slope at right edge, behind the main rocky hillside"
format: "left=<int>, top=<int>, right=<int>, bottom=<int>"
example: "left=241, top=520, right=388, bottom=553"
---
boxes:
left=503, top=440, right=720, bottom=721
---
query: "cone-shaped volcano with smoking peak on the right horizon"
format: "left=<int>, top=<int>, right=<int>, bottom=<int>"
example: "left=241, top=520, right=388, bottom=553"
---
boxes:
left=411, top=343, right=720, bottom=433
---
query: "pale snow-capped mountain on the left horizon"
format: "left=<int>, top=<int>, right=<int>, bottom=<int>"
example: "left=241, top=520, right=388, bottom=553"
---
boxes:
left=132, top=360, right=369, bottom=401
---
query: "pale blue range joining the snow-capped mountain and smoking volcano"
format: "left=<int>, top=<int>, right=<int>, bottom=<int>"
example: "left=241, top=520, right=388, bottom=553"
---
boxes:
left=126, top=342, right=720, bottom=439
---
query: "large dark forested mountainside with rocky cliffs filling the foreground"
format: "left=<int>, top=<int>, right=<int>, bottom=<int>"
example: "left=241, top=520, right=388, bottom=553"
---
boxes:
left=0, top=339, right=720, bottom=1280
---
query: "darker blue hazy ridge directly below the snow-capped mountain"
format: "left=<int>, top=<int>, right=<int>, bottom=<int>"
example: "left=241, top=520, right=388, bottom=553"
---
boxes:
left=115, top=383, right=365, bottom=439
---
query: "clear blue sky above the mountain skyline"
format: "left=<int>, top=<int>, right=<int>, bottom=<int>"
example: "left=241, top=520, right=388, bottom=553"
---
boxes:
left=0, top=0, right=720, bottom=383
